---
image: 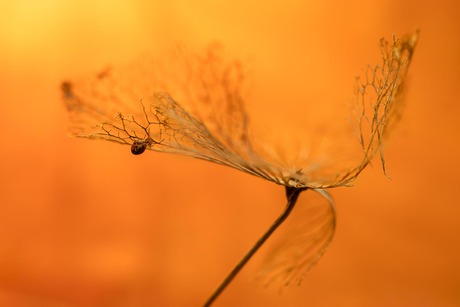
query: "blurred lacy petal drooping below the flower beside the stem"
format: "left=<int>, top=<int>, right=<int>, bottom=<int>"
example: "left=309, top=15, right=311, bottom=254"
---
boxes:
left=258, top=190, right=336, bottom=285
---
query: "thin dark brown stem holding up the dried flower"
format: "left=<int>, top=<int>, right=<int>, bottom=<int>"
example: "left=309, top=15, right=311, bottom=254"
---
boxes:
left=203, top=187, right=306, bottom=307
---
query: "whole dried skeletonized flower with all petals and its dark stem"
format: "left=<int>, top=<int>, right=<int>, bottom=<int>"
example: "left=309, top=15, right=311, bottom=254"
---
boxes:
left=61, top=32, right=418, bottom=306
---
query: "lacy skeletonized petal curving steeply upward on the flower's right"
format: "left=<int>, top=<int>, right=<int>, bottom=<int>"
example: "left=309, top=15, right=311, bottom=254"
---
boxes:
left=299, top=32, right=418, bottom=188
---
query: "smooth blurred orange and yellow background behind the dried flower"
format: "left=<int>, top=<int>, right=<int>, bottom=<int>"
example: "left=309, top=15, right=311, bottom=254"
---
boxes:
left=0, top=0, right=460, bottom=306
